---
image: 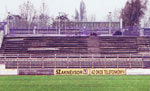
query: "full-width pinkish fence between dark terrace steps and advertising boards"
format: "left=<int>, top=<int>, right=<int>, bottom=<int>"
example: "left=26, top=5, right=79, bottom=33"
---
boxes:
left=0, top=54, right=150, bottom=69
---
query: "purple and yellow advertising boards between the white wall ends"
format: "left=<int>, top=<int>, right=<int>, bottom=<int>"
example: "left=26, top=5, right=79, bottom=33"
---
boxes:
left=18, top=69, right=126, bottom=75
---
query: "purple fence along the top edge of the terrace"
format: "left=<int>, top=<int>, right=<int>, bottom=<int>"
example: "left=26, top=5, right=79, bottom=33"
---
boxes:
left=10, top=28, right=120, bottom=35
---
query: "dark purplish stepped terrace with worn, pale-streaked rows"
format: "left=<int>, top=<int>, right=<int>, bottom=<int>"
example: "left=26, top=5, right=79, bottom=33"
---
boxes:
left=1, top=36, right=150, bottom=54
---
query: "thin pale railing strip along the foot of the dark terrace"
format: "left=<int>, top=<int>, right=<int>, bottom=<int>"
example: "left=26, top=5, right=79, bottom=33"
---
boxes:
left=0, top=54, right=150, bottom=58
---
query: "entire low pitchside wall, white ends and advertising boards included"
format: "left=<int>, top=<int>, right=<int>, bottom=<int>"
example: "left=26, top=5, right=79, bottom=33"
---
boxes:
left=0, top=68, right=150, bottom=76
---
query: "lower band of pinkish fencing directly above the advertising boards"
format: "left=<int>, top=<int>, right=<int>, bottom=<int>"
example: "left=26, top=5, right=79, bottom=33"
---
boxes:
left=4, top=59, right=144, bottom=69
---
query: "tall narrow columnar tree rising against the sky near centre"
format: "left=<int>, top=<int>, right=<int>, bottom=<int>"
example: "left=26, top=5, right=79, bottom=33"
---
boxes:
left=80, top=0, right=87, bottom=21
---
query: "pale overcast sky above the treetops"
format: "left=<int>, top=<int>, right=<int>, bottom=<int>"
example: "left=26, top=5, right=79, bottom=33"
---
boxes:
left=0, top=0, right=148, bottom=20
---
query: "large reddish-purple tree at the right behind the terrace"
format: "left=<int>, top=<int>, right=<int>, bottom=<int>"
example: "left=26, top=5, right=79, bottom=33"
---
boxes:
left=121, top=0, right=147, bottom=26
